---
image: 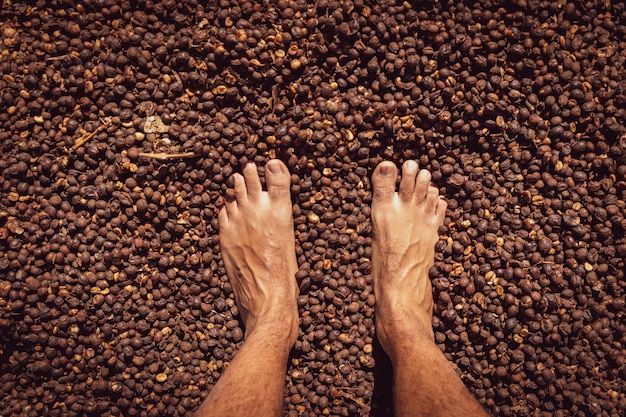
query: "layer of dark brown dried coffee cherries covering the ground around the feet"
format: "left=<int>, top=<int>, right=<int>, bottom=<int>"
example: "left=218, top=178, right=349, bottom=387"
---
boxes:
left=0, top=0, right=626, bottom=416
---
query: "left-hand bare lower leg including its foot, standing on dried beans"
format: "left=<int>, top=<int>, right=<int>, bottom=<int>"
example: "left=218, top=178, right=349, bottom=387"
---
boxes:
left=196, top=160, right=298, bottom=417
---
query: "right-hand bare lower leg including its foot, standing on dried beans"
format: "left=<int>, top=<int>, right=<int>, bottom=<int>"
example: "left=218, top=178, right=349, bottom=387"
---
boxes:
left=372, top=161, right=486, bottom=416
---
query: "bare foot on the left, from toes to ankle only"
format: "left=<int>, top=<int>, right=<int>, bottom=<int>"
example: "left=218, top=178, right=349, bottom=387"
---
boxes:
left=219, top=159, right=298, bottom=342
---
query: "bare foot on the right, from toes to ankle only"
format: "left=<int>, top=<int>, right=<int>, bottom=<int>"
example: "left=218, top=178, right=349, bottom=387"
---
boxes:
left=372, top=161, right=447, bottom=353
